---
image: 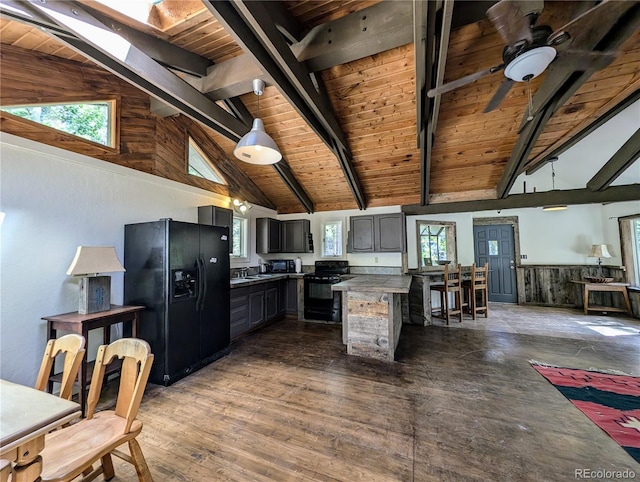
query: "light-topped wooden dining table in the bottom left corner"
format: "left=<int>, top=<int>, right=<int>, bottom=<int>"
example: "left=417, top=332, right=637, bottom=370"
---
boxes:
left=0, top=380, right=82, bottom=482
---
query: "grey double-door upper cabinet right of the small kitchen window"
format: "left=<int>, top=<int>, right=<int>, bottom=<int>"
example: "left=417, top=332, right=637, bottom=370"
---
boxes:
left=349, top=213, right=407, bottom=253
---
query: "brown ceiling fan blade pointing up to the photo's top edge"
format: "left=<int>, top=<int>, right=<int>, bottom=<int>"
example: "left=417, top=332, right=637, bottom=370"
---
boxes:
left=487, top=0, right=544, bottom=45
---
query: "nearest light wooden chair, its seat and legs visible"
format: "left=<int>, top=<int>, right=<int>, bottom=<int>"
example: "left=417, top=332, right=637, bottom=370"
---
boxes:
left=41, top=338, right=153, bottom=482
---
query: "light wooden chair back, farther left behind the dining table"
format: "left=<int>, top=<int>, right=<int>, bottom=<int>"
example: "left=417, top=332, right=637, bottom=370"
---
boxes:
left=35, top=333, right=85, bottom=400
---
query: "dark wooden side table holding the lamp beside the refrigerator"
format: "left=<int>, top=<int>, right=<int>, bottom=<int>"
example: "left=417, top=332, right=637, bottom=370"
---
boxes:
left=42, top=305, right=145, bottom=415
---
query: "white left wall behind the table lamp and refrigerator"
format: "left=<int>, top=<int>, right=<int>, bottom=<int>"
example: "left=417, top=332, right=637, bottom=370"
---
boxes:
left=0, top=133, right=241, bottom=385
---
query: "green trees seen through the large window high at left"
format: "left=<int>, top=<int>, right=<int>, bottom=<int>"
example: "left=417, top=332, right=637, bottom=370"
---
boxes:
left=2, top=101, right=114, bottom=147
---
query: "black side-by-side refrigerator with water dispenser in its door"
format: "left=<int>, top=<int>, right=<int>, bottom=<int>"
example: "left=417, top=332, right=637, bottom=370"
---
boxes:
left=124, top=219, right=230, bottom=386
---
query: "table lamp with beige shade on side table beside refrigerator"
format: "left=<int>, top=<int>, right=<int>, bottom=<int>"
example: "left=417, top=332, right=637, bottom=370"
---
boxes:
left=67, top=246, right=125, bottom=315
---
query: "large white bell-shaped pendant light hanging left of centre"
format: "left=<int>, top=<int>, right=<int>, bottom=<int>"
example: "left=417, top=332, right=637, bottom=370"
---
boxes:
left=233, top=79, right=282, bottom=165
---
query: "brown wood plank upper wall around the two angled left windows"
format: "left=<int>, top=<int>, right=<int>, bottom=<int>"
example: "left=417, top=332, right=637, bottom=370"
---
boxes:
left=0, top=45, right=273, bottom=207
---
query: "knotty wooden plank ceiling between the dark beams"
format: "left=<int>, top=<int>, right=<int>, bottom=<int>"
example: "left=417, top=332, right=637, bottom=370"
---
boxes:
left=0, top=0, right=640, bottom=213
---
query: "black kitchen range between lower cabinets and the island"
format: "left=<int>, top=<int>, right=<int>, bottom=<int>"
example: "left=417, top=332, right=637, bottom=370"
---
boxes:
left=304, top=261, right=349, bottom=323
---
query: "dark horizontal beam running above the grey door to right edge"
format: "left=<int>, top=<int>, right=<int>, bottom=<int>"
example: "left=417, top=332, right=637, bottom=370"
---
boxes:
left=402, top=184, right=640, bottom=215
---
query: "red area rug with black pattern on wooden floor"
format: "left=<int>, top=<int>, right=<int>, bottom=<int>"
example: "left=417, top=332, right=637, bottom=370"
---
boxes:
left=531, top=362, right=640, bottom=463
